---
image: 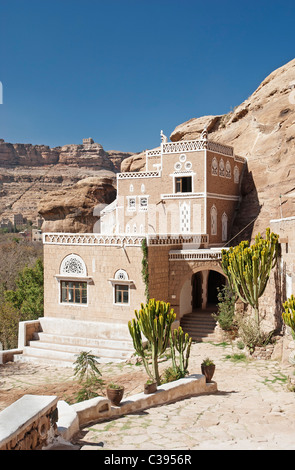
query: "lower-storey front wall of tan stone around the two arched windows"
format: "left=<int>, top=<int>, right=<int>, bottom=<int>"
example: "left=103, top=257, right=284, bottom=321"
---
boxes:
left=44, top=244, right=145, bottom=323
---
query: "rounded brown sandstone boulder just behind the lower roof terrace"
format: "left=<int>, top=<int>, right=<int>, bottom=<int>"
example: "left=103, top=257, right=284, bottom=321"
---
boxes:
left=38, top=177, right=116, bottom=233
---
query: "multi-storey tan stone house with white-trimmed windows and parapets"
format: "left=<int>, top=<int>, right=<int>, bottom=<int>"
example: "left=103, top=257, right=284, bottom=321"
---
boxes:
left=16, top=131, right=246, bottom=366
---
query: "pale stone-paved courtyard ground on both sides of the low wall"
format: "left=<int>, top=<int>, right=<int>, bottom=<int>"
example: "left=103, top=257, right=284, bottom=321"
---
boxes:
left=0, top=343, right=295, bottom=450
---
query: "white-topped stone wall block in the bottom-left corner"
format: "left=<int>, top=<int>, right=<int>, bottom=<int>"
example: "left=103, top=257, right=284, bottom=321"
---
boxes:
left=0, top=395, right=58, bottom=450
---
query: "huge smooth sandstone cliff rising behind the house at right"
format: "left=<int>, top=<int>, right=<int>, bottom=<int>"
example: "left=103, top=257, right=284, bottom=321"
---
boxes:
left=122, top=59, right=295, bottom=238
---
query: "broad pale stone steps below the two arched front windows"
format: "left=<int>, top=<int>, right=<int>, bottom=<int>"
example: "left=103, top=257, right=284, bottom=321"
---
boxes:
left=14, top=318, right=134, bottom=367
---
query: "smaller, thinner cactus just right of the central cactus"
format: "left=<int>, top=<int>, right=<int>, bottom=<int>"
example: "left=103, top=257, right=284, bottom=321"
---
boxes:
left=170, top=326, right=192, bottom=377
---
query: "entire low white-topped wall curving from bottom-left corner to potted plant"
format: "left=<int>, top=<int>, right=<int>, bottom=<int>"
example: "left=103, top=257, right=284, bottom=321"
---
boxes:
left=0, top=374, right=217, bottom=450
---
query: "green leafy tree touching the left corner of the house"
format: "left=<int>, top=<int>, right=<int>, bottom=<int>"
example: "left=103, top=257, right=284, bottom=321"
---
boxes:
left=4, top=259, right=44, bottom=320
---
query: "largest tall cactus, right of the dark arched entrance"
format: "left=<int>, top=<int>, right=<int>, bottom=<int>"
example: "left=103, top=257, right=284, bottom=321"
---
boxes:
left=222, top=228, right=279, bottom=328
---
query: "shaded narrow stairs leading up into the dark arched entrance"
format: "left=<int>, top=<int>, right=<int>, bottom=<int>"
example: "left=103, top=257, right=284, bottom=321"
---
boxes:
left=180, top=308, right=216, bottom=342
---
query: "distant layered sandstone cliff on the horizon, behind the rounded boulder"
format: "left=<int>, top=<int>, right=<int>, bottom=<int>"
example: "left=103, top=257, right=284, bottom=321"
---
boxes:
left=0, top=139, right=133, bottom=226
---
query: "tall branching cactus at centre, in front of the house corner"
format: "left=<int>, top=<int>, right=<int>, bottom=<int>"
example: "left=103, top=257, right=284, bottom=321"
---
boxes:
left=128, top=299, right=176, bottom=385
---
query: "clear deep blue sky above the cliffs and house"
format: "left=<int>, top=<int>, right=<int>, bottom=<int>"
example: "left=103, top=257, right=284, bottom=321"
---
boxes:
left=0, top=0, right=295, bottom=152
